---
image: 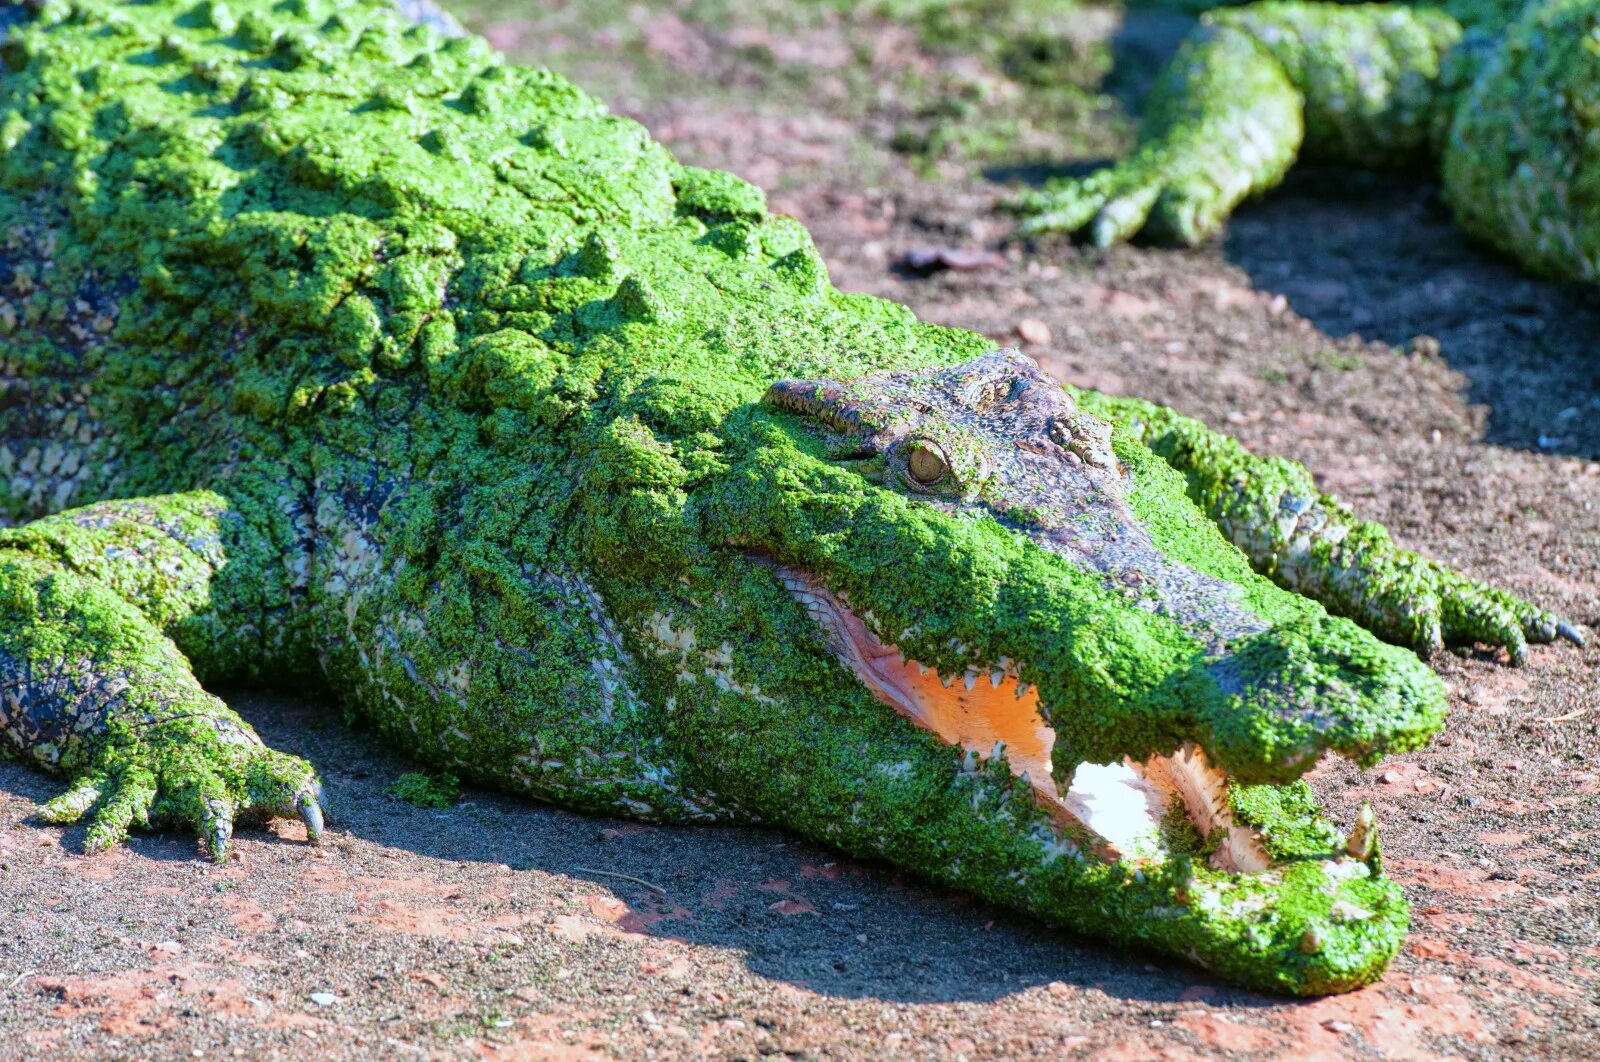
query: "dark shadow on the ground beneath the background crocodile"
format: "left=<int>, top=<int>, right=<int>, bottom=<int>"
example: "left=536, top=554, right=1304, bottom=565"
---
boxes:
left=1224, top=168, right=1600, bottom=457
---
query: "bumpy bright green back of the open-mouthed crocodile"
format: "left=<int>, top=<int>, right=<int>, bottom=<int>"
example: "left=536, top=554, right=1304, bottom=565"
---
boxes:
left=0, top=0, right=987, bottom=518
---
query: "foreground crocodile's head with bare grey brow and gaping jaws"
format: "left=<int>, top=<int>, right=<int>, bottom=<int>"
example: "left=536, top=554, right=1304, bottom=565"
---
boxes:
left=710, top=350, right=1443, bottom=992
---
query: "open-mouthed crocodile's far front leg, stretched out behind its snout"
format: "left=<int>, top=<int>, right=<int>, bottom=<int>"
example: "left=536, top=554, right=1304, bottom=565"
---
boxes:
left=1078, top=390, right=1582, bottom=664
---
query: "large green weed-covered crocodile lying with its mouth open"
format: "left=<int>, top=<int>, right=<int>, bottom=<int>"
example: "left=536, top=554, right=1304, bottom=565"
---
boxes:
left=0, top=0, right=1574, bottom=993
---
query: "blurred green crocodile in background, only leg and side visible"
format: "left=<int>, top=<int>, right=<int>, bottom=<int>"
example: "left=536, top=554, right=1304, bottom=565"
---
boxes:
left=1018, top=0, right=1600, bottom=283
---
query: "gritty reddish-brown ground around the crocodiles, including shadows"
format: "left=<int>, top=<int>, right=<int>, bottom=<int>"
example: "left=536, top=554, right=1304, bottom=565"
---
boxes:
left=0, top=0, right=1600, bottom=1062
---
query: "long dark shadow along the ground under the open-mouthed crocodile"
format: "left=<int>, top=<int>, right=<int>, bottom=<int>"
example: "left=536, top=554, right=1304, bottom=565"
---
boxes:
left=0, top=694, right=1277, bottom=1006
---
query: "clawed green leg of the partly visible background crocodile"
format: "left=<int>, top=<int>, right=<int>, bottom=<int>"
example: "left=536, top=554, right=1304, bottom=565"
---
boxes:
left=1018, top=3, right=1461, bottom=246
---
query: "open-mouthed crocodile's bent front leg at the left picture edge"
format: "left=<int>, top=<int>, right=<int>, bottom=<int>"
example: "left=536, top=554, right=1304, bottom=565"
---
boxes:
left=0, top=491, right=323, bottom=859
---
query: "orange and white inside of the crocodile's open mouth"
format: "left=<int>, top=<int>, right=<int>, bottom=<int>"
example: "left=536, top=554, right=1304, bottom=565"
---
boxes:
left=768, top=561, right=1292, bottom=873
